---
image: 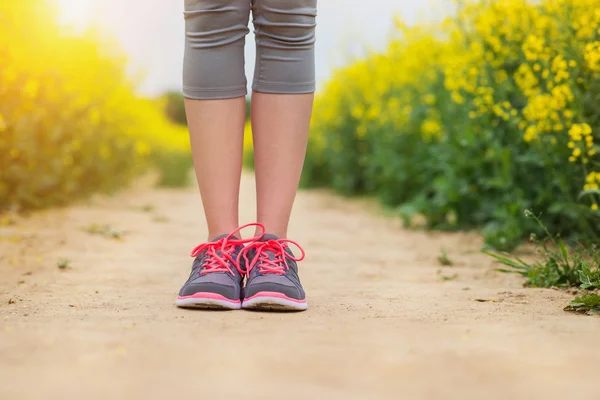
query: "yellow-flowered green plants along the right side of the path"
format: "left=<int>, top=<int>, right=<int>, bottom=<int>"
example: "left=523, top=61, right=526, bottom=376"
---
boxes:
left=303, top=0, right=600, bottom=249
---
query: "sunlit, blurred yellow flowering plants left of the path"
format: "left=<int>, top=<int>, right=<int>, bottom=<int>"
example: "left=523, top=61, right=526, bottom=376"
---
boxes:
left=0, top=0, right=189, bottom=211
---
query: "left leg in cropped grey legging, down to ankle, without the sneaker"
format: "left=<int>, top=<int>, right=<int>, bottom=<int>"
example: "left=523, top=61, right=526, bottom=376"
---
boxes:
left=183, top=0, right=250, bottom=240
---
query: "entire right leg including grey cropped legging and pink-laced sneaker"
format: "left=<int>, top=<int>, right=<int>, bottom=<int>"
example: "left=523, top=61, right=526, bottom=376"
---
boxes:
left=237, top=0, right=317, bottom=311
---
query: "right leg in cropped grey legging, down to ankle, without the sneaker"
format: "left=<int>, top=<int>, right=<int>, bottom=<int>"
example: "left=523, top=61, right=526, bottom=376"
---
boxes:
left=252, top=0, right=317, bottom=238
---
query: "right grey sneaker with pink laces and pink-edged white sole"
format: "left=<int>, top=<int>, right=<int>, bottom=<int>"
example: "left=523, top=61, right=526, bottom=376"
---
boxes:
left=240, top=234, right=308, bottom=311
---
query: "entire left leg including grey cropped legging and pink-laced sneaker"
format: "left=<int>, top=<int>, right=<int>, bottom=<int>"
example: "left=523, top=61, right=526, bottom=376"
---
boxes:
left=176, top=0, right=254, bottom=309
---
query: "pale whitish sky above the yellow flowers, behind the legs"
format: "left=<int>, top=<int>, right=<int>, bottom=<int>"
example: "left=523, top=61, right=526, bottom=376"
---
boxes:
left=56, top=0, right=449, bottom=96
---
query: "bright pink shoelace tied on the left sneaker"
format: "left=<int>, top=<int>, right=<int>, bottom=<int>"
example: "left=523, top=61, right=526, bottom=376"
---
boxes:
left=190, top=223, right=265, bottom=275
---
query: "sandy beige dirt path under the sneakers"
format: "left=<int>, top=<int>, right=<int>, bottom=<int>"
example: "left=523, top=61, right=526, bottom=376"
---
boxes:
left=0, top=176, right=600, bottom=400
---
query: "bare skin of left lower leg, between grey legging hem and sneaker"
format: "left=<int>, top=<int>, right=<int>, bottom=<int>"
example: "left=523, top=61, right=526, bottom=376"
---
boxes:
left=185, top=97, right=246, bottom=240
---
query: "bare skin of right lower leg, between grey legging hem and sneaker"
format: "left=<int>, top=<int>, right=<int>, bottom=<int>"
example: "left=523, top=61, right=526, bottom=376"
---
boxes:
left=252, top=92, right=314, bottom=238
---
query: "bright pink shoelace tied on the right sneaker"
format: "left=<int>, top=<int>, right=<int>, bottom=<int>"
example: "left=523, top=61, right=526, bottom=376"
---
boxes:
left=240, top=239, right=306, bottom=275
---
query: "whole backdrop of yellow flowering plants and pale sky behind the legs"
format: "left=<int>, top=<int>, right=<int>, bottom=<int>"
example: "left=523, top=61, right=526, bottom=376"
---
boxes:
left=0, top=0, right=600, bottom=250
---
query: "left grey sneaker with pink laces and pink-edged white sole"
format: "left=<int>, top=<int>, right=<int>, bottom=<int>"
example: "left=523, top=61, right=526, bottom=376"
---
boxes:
left=175, top=224, right=264, bottom=310
